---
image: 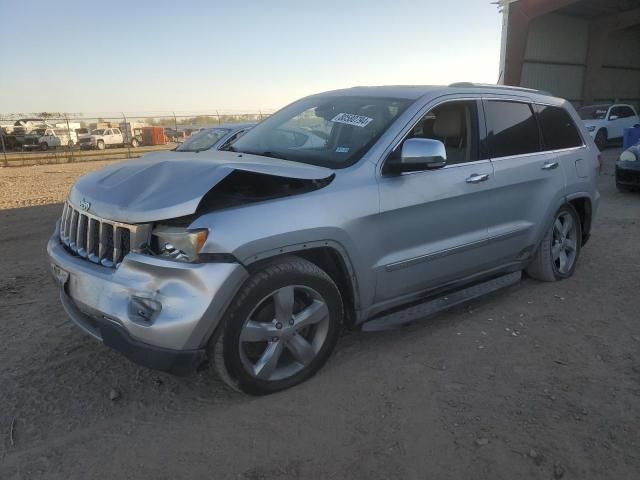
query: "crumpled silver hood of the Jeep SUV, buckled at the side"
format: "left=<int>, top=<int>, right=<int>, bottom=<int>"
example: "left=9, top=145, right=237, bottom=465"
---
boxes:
left=69, top=151, right=334, bottom=223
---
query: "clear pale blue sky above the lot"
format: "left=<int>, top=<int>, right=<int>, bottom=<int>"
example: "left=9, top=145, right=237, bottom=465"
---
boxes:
left=0, top=0, right=501, bottom=115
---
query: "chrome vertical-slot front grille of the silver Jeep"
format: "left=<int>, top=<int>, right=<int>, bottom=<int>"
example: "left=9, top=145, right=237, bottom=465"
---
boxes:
left=60, top=201, right=151, bottom=268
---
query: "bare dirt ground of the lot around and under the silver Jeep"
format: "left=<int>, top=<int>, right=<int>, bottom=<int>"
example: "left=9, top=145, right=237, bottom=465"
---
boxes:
left=0, top=149, right=640, bottom=480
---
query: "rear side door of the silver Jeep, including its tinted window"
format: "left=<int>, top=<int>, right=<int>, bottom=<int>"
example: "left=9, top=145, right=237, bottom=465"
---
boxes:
left=483, top=99, right=565, bottom=265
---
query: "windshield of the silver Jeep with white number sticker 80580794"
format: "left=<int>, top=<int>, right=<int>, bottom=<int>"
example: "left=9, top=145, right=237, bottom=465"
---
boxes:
left=229, top=96, right=411, bottom=168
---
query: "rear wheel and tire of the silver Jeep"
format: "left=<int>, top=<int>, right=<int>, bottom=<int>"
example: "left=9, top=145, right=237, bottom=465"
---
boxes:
left=525, top=204, right=582, bottom=282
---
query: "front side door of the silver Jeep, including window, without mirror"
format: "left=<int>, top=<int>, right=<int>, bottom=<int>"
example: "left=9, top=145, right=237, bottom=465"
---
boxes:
left=375, top=100, right=494, bottom=303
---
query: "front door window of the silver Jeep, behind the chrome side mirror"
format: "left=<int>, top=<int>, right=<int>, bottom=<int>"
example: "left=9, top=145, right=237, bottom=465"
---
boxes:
left=393, top=101, right=479, bottom=164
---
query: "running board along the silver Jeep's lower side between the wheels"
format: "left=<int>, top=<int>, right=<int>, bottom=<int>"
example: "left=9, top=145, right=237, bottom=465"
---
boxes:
left=361, top=272, right=522, bottom=332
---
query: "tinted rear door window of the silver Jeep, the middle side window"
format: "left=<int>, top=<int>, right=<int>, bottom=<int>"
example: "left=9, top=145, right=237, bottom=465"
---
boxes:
left=485, top=100, right=540, bottom=158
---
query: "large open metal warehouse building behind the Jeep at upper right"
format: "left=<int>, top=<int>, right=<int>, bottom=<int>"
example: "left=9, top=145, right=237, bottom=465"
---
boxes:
left=498, top=0, right=640, bottom=106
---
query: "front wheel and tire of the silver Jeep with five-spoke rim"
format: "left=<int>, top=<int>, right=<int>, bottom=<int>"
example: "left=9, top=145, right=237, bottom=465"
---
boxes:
left=208, top=256, right=343, bottom=395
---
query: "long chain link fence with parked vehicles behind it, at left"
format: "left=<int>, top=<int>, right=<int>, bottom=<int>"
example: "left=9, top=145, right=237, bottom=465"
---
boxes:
left=0, top=111, right=270, bottom=167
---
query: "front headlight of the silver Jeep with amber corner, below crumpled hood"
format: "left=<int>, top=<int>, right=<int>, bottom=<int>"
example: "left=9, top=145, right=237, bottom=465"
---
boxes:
left=151, top=225, right=209, bottom=262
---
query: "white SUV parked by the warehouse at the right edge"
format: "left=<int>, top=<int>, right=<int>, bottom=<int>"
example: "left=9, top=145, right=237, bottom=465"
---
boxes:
left=578, top=104, right=640, bottom=150
